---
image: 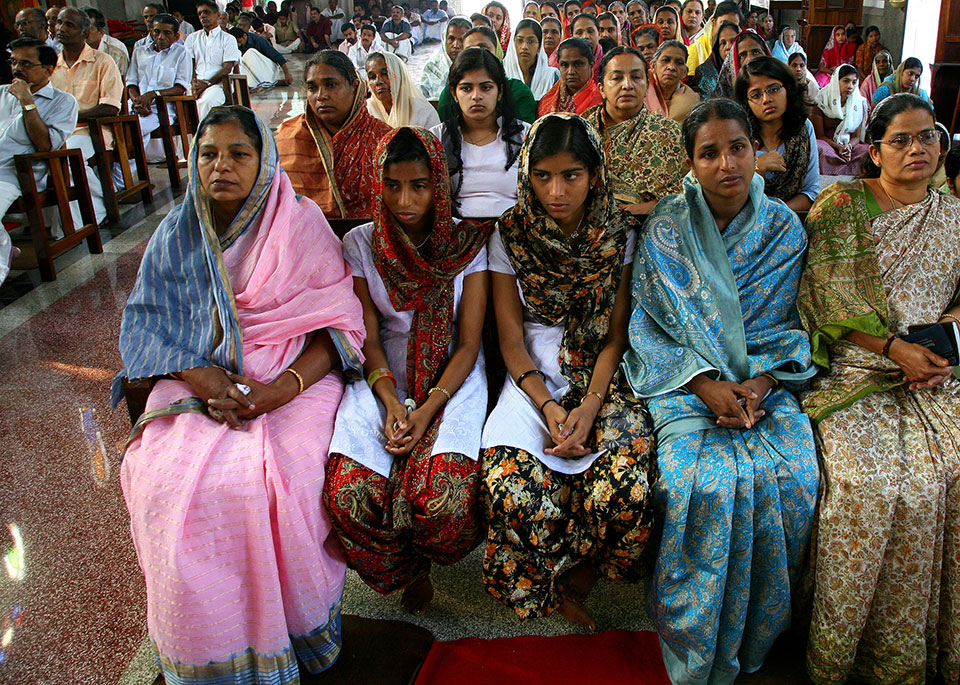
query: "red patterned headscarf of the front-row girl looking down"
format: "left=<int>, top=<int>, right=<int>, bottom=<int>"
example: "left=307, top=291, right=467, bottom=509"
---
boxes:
left=371, top=126, right=492, bottom=406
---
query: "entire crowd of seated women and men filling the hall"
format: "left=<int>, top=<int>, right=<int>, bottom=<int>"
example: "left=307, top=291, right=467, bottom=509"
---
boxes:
left=0, top=0, right=960, bottom=683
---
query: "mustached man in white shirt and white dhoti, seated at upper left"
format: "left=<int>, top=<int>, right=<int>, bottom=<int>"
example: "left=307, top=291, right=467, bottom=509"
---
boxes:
left=185, top=0, right=240, bottom=121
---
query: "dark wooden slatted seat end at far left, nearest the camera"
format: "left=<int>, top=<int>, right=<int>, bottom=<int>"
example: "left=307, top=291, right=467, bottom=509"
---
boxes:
left=7, top=149, right=103, bottom=281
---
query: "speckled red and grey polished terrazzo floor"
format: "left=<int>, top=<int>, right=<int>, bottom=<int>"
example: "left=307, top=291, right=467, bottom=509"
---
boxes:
left=0, top=46, right=804, bottom=685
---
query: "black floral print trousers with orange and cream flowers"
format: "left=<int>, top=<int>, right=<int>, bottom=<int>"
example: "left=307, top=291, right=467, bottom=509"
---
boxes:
left=480, top=446, right=651, bottom=618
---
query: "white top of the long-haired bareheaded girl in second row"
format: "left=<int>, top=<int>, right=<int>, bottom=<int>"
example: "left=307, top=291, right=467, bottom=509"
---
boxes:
left=430, top=122, right=530, bottom=217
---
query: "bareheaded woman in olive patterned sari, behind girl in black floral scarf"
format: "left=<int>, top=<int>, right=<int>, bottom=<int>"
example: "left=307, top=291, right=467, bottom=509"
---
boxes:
left=583, top=46, right=687, bottom=215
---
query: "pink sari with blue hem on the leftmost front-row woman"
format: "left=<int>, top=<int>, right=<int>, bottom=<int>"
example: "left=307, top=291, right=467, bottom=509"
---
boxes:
left=121, top=139, right=364, bottom=683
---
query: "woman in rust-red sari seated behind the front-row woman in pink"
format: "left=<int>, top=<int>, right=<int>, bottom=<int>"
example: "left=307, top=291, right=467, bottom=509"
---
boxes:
left=277, top=50, right=390, bottom=218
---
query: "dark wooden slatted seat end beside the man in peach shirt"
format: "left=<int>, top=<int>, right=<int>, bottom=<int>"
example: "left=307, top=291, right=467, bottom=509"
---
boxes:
left=90, top=114, right=153, bottom=223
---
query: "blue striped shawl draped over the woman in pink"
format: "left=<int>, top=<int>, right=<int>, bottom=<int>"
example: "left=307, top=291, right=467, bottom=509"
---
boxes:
left=111, top=108, right=361, bottom=412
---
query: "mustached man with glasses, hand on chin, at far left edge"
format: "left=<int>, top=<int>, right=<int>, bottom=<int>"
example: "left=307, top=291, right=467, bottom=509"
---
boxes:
left=0, top=38, right=78, bottom=283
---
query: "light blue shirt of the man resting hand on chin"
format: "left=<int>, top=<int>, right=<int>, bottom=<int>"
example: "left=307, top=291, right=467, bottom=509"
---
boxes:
left=0, top=83, right=79, bottom=184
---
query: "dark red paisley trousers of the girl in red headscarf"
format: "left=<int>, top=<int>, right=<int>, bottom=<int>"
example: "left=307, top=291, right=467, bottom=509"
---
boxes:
left=323, top=451, right=480, bottom=595
